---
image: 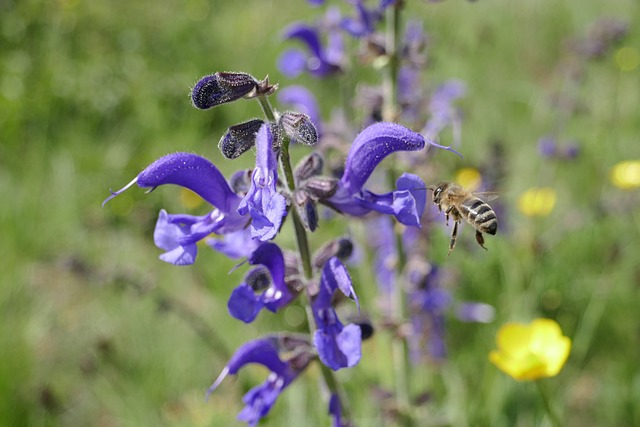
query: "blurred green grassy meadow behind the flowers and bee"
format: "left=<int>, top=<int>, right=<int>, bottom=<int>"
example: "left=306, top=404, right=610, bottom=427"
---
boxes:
left=0, top=0, right=640, bottom=426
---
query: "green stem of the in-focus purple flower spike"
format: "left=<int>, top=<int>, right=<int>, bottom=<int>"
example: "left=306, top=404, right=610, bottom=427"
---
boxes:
left=258, top=96, right=350, bottom=421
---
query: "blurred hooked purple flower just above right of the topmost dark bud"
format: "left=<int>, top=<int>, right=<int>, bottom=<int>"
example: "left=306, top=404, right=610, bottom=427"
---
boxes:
left=278, top=18, right=344, bottom=78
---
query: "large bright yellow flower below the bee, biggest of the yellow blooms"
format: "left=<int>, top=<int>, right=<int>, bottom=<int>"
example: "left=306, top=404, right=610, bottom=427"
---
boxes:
left=489, top=319, right=571, bottom=381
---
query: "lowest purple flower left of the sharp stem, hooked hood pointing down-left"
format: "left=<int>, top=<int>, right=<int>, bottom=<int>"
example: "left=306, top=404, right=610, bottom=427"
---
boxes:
left=207, top=335, right=313, bottom=427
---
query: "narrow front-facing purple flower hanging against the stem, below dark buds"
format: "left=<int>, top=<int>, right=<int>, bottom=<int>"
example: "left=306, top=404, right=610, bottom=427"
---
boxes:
left=238, top=124, right=287, bottom=241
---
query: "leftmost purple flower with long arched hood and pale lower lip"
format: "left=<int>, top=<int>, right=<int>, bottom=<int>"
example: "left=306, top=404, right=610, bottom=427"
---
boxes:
left=102, top=153, right=249, bottom=265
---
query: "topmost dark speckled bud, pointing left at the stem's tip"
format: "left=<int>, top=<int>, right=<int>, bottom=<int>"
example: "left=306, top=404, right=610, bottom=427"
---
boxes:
left=191, top=72, right=259, bottom=110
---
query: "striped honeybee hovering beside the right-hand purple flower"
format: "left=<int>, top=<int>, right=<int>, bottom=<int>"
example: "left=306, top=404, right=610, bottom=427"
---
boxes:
left=429, top=182, right=498, bottom=256
